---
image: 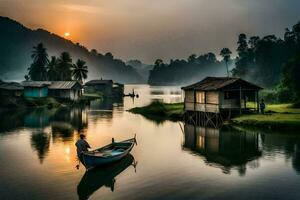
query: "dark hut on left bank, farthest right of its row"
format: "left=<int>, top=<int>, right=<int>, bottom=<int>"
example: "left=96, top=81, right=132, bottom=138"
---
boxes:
left=85, top=79, right=124, bottom=97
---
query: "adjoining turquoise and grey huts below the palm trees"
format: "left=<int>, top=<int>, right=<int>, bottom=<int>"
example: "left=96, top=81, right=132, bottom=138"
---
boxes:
left=22, top=81, right=82, bottom=100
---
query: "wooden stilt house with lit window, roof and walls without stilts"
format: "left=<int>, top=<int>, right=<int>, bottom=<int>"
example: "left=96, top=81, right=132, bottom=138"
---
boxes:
left=182, top=77, right=262, bottom=113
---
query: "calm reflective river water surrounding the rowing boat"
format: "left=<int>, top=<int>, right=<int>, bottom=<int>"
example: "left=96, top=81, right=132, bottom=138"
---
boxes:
left=0, top=85, right=300, bottom=200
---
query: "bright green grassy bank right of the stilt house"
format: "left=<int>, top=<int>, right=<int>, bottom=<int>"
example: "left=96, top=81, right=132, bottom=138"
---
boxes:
left=232, top=104, right=300, bottom=130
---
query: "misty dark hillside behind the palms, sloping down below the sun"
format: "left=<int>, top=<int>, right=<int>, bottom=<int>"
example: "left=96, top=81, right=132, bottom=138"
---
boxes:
left=0, top=16, right=143, bottom=83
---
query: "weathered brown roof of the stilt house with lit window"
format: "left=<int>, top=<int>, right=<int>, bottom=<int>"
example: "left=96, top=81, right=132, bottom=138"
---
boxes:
left=182, top=77, right=262, bottom=91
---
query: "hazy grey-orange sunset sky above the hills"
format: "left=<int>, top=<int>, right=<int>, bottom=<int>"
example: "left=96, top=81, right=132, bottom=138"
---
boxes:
left=0, top=0, right=300, bottom=63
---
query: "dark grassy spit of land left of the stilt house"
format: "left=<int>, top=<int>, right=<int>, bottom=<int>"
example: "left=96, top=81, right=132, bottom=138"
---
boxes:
left=129, top=102, right=183, bottom=122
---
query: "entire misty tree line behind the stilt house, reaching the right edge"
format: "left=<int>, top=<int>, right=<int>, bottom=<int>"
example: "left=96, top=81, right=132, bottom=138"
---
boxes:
left=148, top=22, right=300, bottom=102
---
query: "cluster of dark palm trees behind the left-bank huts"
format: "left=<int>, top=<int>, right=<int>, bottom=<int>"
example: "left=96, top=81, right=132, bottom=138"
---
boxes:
left=25, top=43, right=88, bottom=83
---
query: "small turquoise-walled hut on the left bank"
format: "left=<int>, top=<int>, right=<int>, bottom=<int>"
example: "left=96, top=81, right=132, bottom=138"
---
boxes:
left=22, top=81, right=51, bottom=97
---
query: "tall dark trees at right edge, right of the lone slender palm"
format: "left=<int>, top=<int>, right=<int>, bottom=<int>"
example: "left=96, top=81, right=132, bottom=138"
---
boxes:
left=232, top=22, right=300, bottom=102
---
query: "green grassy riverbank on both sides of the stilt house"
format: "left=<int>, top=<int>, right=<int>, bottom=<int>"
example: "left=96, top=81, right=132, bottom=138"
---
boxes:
left=129, top=102, right=300, bottom=130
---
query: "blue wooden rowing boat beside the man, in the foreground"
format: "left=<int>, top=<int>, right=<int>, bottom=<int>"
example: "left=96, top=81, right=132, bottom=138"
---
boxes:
left=82, top=135, right=137, bottom=170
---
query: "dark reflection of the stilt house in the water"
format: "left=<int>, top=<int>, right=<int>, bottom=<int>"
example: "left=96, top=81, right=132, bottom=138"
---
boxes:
left=184, top=124, right=261, bottom=175
